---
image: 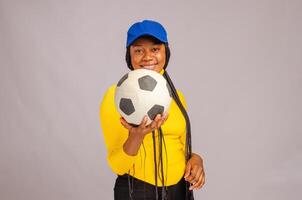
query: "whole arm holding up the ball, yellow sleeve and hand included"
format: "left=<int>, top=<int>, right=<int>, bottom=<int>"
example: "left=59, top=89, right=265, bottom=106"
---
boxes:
left=100, top=87, right=167, bottom=175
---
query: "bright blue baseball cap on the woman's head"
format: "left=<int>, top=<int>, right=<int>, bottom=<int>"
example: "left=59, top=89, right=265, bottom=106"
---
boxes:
left=126, top=20, right=168, bottom=47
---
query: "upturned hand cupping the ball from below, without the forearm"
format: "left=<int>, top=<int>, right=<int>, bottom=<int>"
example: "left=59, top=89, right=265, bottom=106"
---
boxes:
left=120, top=112, right=168, bottom=137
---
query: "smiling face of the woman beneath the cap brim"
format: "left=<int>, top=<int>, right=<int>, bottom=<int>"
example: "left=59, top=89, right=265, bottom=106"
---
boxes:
left=130, top=37, right=166, bottom=72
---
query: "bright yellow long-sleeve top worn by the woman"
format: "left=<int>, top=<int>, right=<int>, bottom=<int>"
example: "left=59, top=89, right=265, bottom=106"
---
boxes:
left=100, top=82, right=187, bottom=186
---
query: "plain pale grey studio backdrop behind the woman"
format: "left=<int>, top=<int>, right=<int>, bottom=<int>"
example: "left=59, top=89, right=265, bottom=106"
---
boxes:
left=0, top=0, right=302, bottom=200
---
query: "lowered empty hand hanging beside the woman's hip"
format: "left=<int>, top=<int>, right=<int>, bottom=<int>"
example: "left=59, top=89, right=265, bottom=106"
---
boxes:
left=184, top=153, right=205, bottom=190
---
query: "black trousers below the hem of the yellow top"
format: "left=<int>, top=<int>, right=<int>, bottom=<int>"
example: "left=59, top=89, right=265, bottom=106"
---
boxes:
left=114, top=175, right=193, bottom=200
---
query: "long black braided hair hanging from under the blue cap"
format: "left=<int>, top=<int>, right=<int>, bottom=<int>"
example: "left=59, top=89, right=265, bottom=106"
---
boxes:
left=125, top=35, right=194, bottom=200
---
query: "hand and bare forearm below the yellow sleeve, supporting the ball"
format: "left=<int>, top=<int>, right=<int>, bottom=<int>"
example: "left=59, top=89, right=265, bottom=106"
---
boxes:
left=121, top=113, right=168, bottom=156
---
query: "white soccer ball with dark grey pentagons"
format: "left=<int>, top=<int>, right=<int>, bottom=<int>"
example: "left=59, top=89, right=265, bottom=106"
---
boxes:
left=114, top=69, right=172, bottom=125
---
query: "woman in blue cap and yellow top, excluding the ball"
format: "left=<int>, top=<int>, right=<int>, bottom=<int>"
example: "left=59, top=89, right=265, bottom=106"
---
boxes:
left=100, top=20, right=205, bottom=200
